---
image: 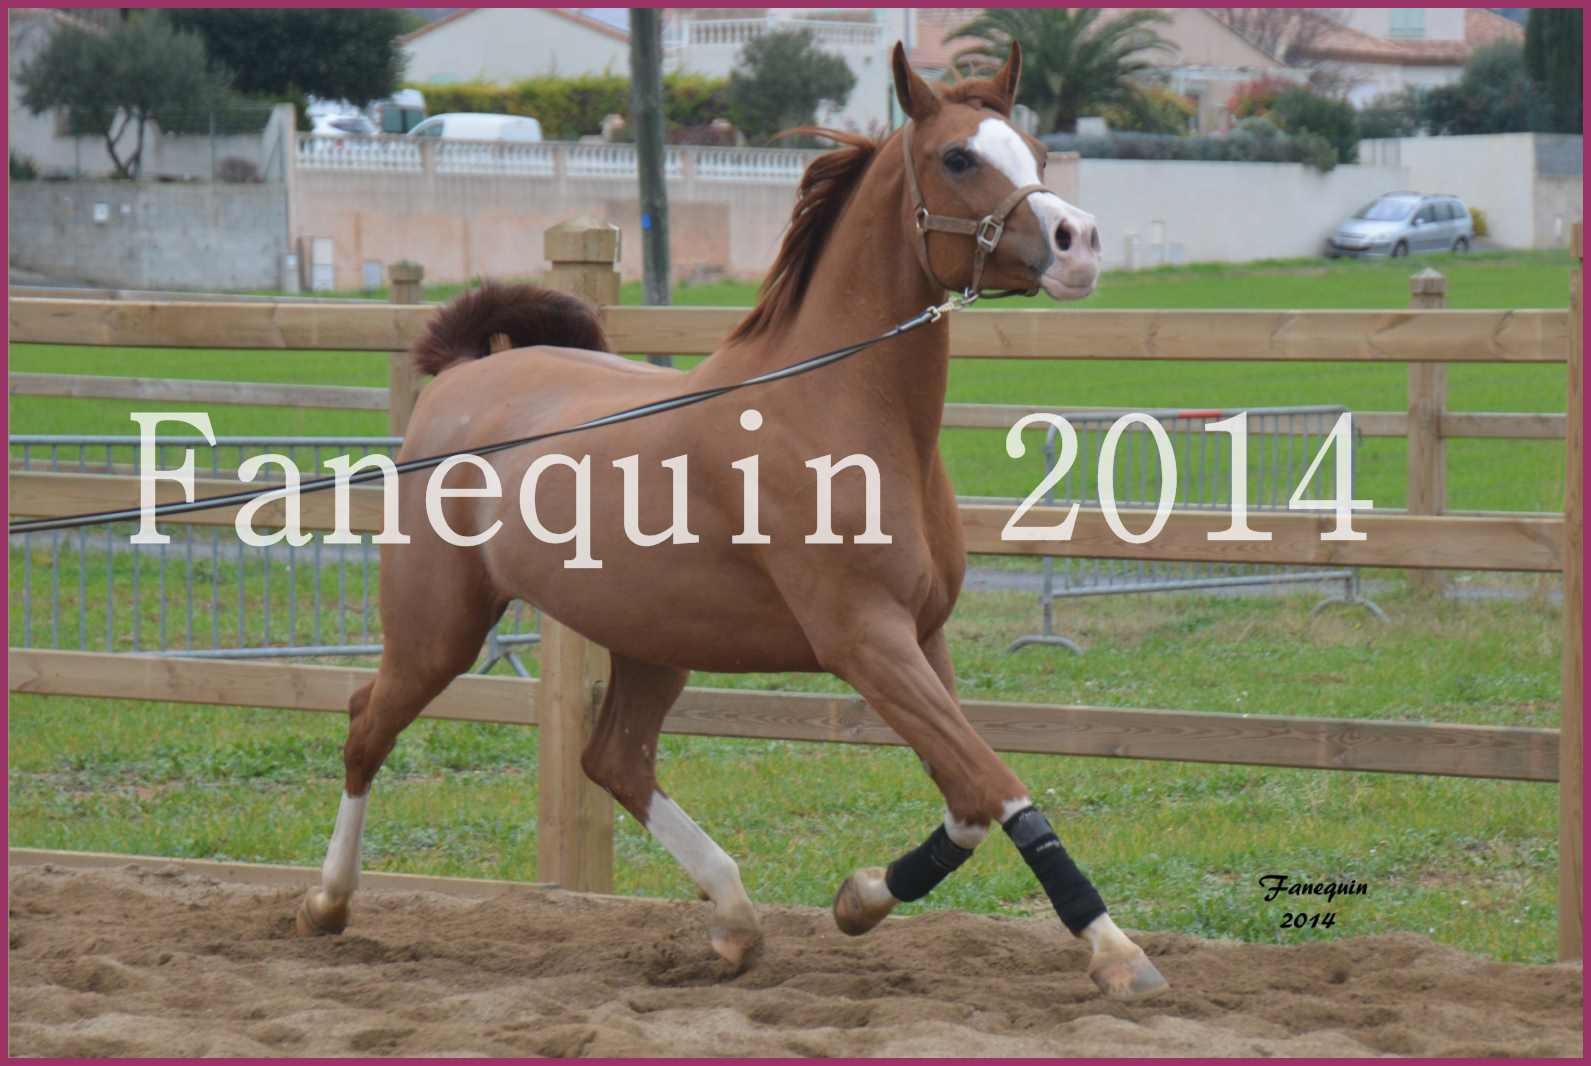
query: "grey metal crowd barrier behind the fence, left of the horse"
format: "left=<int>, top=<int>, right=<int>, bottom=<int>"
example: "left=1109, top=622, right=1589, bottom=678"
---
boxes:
left=10, top=434, right=541, bottom=676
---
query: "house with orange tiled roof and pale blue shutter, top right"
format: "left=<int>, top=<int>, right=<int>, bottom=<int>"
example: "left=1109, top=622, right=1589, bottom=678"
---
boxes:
left=1297, top=8, right=1524, bottom=107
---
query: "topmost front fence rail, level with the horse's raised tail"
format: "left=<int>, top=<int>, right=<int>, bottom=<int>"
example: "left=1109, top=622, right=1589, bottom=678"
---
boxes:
left=10, top=298, right=1569, bottom=364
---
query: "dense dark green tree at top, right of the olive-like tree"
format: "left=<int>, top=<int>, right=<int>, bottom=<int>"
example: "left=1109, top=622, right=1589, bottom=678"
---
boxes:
left=170, top=8, right=407, bottom=105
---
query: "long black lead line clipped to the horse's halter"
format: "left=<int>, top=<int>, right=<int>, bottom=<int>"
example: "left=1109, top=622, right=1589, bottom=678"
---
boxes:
left=6, top=299, right=948, bottom=536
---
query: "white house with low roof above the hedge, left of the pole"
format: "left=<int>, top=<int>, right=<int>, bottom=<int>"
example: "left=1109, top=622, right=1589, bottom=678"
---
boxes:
left=398, top=8, right=630, bottom=84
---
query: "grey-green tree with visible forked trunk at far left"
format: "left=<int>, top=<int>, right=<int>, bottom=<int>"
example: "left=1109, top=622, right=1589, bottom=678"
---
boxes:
left=18, top=13, right=228, bottom=180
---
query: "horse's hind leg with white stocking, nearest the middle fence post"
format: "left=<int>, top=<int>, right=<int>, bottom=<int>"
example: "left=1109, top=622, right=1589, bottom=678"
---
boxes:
left=581, top=656, right=762, bottom=971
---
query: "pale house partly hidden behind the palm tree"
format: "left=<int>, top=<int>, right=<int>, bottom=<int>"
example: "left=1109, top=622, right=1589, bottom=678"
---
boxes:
left=910, top=8, right=1303, bottom=132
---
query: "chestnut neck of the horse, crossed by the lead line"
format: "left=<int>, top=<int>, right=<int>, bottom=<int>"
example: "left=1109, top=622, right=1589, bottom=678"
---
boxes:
left=719, top=157, right=950, bottom=461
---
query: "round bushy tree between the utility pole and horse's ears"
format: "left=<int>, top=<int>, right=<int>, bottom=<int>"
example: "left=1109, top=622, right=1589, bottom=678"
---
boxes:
left=729, top=30, right=856, bottom=140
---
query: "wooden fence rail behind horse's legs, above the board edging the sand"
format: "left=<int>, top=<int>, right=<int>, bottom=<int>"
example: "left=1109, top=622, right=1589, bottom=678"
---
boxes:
left=10, top=645, right=1559, bottom=789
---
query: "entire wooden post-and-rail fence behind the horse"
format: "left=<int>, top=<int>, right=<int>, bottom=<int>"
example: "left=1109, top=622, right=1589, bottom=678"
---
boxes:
left=10, top=224, right=1583, bottom=958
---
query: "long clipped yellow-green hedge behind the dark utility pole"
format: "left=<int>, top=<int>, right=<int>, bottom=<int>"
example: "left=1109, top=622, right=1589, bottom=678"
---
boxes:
left=409, top=73, right=729, bottom=140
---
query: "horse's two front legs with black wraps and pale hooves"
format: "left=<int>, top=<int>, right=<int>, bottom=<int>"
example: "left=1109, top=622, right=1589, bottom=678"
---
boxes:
left=824, top=619, right=1166, bottom=998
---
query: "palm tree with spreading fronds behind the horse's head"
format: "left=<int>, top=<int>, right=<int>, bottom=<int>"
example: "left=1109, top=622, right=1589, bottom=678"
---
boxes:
left=950, top=8, right=1174, bottom=134
